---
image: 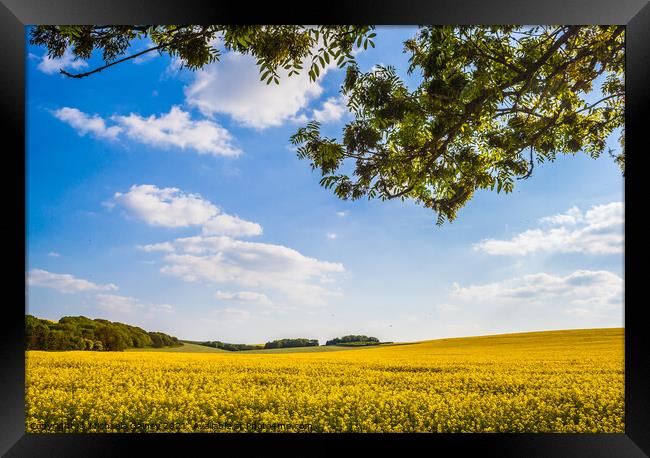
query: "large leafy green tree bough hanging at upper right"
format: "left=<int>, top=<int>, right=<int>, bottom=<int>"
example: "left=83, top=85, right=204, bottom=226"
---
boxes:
left=292, top=26, right=624, bottom=223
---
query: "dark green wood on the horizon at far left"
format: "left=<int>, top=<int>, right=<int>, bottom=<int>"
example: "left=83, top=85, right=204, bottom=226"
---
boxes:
left=25, top=315, right=183, bottom=351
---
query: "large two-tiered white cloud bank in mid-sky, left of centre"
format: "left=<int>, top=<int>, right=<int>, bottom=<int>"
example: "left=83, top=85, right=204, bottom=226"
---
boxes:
left=112, top=185, right=345, bottom=305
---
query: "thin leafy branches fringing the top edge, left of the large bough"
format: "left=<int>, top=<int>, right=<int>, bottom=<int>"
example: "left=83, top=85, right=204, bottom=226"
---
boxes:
left=30, top=25, right=375, bottom=84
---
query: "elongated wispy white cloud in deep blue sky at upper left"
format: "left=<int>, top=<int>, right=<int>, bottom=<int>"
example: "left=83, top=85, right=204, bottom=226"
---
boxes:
left=53, top=106, right=241, bottom=157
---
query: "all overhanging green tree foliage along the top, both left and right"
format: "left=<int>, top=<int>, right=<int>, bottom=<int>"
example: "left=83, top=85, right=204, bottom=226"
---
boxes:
left=31, top=26, right=625, bottom=224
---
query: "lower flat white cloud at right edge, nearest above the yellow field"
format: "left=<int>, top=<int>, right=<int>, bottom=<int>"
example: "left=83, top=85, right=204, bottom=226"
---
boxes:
left=450, top=270, right=623, bottom=309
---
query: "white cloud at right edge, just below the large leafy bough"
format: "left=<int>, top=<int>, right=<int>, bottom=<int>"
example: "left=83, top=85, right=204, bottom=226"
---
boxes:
left=474, top=202, right=625, bottom=256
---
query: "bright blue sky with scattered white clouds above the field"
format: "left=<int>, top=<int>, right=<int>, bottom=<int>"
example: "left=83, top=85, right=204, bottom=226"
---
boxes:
left=26, top=27, right=623, bottom=343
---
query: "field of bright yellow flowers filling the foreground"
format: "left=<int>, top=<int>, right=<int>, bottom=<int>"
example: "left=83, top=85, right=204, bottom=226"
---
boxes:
left=26, top=329, right=624, bottom=433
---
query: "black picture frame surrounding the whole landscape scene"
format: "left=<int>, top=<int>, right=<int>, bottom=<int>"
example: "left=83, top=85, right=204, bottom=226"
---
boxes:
left=0, top=0, right=650, bottom=457
